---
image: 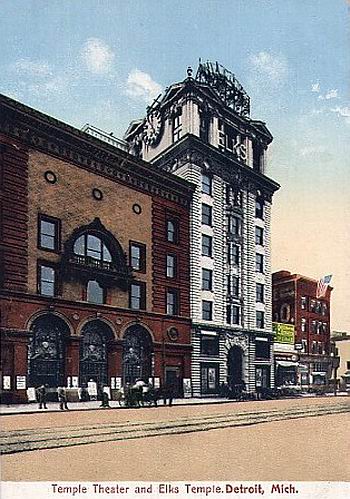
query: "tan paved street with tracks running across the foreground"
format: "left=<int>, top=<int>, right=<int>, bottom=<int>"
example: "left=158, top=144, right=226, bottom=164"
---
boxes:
left=0, top=397, right=350, bottom=481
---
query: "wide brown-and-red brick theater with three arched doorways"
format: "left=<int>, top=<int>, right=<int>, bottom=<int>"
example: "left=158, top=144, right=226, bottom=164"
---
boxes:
left=0, top=96, right=193, bottom=401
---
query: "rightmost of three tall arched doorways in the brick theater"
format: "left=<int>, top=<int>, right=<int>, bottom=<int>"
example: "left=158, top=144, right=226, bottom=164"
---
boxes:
left=123, top=325, right=152, bottom=385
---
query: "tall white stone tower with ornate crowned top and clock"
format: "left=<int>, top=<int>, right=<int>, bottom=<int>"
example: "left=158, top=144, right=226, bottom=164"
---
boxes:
left=125, top=62, right=279, bottom=396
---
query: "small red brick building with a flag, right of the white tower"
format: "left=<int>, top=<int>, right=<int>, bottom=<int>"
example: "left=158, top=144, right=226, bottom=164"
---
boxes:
left=272, top=270, right=332, bottom=386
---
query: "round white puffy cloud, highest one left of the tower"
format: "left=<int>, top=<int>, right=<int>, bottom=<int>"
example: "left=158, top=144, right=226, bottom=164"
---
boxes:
left=80, top=38, right=115, bottom=74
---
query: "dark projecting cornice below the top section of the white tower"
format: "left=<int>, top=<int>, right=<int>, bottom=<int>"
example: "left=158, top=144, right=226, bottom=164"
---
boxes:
left=152, top=134, right=280, bottom=200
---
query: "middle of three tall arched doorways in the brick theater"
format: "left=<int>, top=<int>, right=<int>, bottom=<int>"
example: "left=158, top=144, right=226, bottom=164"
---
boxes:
left=79, top=320, right=113, bottom=386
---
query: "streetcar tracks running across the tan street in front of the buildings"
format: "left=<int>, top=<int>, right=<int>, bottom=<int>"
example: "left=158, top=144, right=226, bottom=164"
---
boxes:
left=0, top=404, right=350, bottom=454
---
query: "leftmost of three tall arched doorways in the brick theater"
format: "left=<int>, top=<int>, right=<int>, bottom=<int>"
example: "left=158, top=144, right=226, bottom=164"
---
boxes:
left=28, top=314, right=69, bottom=387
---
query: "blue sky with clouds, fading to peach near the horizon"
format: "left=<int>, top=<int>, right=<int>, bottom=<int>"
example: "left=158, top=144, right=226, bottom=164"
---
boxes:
left=0, top=0, right=350, bottom=330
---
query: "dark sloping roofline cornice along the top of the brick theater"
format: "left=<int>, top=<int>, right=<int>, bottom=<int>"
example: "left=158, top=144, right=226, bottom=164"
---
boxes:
left=0, top=94, right=194, bottom=207
